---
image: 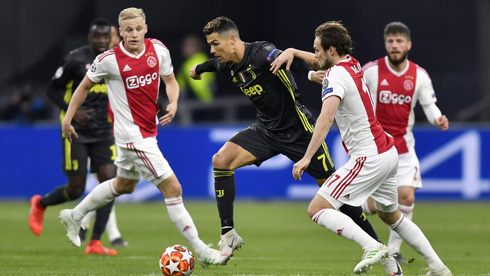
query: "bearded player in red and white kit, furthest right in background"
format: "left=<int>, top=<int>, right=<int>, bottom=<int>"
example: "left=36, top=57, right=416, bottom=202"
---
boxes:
left=363, top=22, right=449, bottom=262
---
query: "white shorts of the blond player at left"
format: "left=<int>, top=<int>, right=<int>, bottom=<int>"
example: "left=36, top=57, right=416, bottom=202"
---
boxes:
left=114, top=137, right=174, bottom=186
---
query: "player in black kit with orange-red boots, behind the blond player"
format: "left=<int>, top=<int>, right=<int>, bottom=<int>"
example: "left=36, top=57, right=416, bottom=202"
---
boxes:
left=29, top=18, right=124, bottom=255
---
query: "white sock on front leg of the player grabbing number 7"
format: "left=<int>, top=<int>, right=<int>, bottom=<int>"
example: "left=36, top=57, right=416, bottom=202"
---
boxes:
left=312, top=208, right=379, bottom=250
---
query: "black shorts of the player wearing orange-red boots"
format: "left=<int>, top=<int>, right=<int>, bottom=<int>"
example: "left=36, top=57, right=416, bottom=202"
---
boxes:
left=61, top=137, right=116, bottom=175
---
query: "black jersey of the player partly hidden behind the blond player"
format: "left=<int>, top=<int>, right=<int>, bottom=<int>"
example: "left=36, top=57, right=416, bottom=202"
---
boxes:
left=48, top=45, right=113, bottom=142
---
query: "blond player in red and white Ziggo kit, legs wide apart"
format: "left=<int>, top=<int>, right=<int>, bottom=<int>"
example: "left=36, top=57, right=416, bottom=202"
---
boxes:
left=59, top=8, right=225, bottom=266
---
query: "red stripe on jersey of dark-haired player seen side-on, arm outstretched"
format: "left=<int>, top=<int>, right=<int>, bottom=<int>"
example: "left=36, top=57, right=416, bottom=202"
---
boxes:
left=337, top=56, right=393, bottom=153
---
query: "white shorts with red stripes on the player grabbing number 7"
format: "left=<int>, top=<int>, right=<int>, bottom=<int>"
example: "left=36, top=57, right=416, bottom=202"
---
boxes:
left=318, top=147, right=398, bottom=212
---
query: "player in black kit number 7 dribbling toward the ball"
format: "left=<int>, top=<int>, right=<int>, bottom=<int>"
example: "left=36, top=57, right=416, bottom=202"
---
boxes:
left=189, top=16, right=394, bottom=270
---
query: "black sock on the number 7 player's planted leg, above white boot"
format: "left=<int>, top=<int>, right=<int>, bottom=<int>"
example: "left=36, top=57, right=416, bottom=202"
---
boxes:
left=213, top=169, right=236, bottom=235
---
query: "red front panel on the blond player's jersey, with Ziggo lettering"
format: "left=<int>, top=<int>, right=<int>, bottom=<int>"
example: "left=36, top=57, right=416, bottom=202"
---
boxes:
left=114, top=39, right=160, bottom=138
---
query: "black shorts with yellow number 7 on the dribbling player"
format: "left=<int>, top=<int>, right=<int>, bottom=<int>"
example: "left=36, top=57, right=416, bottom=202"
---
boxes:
left=229, top=124, right=335, bottom=179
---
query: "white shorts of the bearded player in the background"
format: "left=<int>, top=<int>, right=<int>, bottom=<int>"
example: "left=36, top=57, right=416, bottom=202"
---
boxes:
left=396, top=149, right=422, bottom=189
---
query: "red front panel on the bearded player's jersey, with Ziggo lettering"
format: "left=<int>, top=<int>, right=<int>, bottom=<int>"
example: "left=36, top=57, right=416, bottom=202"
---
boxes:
left=376, top=58, right=417, bottom=154
